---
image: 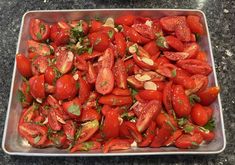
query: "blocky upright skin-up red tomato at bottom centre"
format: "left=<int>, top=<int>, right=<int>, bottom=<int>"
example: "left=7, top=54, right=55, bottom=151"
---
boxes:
left=102, top=109, right=120, bottom=139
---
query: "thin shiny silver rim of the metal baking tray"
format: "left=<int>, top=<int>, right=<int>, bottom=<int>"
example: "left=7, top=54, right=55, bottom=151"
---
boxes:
left=2, top=8, right=227, bottom=157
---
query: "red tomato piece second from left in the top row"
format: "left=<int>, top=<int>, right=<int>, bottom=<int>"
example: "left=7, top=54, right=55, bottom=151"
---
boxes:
left=50, top=21, right=70, bottom=46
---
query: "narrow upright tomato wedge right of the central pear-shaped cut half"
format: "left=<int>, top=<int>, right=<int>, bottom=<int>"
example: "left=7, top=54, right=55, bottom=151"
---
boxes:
left=114, top=59, right=127, bottom=89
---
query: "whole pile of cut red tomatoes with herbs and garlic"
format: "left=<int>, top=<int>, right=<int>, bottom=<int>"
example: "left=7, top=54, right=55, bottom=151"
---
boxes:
left=16, top=15, right=219, bottom=153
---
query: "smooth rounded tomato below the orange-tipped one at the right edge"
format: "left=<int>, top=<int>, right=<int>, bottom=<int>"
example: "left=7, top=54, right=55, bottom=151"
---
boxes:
left=191, top=104, right=209, bottom=126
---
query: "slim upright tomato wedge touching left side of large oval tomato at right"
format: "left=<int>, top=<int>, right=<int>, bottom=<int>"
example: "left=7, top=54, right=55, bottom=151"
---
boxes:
left=162, top=81, right=173, bottom=114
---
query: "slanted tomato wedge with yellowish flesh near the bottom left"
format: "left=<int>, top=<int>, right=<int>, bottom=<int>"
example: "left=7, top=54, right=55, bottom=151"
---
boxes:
left=76, top=120, right=99, bottom=144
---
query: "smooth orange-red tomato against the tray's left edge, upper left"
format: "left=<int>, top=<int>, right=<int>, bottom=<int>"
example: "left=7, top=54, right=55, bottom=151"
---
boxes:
left=16, top=54, right=32, bottom=77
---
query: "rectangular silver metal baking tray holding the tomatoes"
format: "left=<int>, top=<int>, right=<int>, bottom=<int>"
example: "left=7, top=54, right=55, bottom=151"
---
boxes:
left=2, top=9, right=226, bottom=156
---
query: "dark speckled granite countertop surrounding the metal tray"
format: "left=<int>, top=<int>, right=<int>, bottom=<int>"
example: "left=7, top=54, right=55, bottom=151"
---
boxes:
left=0, top=0, right=235, bottom=165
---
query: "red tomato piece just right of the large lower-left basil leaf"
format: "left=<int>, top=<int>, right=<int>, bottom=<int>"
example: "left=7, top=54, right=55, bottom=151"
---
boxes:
left=79, top=108, right=101, bottom=122
